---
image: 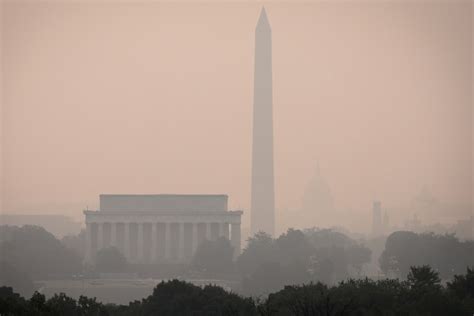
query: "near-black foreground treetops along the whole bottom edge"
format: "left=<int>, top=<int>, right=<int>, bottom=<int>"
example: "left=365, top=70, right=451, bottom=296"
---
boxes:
left=0, top=266, right=474, bottom=316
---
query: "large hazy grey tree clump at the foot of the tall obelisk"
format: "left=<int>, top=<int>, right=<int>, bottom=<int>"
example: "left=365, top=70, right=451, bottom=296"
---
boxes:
left=237, top=229, right=370, bottom=294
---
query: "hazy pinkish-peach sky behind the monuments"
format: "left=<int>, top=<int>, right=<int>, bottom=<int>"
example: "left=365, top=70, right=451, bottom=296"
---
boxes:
left=1, top=1, right=473, bottom=232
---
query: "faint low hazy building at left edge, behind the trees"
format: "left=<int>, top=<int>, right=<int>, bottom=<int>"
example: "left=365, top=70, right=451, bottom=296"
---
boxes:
left=0, top=214, right=82, bottom=238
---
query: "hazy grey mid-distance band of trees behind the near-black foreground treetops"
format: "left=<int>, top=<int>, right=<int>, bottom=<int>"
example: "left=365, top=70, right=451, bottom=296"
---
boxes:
left=0, top=226, right=474, bottom=296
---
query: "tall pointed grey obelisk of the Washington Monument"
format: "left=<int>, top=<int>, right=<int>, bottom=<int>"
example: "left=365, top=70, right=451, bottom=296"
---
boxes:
left=251, top=8, right=275, bottom=236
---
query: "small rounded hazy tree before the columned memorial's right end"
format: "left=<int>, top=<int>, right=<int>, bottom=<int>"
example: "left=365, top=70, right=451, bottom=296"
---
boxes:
left=193, top=237, right=234, bottom=272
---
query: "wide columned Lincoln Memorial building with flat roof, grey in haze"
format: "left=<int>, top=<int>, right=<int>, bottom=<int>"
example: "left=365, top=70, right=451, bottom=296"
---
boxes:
left=84, top=194, right=242, bottom=263
